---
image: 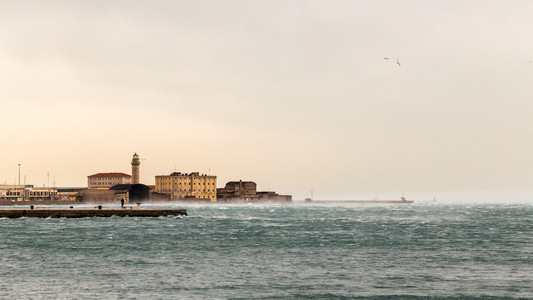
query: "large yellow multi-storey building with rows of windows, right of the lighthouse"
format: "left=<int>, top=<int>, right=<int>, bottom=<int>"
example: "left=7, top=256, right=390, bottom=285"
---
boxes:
left=155, top=172, right=217, bottom=202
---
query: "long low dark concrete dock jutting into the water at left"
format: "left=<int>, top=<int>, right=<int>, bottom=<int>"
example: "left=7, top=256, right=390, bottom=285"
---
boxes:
left=0, top=208, right=187, bottom=218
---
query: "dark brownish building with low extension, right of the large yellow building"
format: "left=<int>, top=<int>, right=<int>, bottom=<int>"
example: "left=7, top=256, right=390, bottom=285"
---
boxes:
left=217, top=180, right=292, bottom=202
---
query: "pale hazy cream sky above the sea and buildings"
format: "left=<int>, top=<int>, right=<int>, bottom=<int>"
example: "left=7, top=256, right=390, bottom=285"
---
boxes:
left=0, top=0, right=533, bottom=201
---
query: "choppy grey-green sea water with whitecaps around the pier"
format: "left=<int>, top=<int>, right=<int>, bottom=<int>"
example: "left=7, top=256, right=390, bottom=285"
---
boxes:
left=0, top=203, right=533, bottom=299
